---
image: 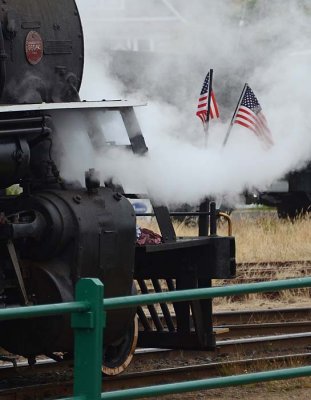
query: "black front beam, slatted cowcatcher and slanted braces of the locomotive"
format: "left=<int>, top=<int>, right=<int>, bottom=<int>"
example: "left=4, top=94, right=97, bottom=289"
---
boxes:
left=114, top=107, right=236, bottom=350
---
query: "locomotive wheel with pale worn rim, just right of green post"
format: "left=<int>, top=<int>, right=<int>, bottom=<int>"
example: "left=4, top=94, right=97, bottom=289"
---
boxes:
left=102, top=315, right=138, bottom=376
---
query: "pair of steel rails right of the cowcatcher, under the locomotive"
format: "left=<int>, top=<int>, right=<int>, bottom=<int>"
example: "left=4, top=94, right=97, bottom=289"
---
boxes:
left=141, top=307, right=311, bottom=357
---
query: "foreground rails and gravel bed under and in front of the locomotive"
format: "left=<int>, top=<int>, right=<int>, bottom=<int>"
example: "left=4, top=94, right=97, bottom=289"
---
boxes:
left=0, top=307, right=311, bottom=400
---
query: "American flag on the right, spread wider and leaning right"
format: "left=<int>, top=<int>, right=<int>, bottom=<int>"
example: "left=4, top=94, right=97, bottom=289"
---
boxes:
left=233, top=85, right=274, bottom=147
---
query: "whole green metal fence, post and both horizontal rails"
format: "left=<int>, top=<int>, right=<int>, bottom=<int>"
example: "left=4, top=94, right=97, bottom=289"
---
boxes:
left=0, top=277, right=311, bottom=400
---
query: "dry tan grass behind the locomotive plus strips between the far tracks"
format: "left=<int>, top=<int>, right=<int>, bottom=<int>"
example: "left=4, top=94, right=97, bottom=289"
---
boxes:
left=138, top=212, right=311, bottom=310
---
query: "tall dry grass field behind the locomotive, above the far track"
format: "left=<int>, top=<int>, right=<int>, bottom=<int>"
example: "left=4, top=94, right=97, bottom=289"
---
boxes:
left=139, top=213, right=311, bottom=262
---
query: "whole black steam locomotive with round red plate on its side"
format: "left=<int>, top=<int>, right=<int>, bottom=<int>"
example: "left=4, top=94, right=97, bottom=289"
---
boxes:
left=0, top=0, right=235, bottom=374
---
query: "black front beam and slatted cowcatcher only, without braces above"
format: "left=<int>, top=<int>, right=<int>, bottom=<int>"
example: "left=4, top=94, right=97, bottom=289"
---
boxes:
left=134, top=216, right=235, bottom=350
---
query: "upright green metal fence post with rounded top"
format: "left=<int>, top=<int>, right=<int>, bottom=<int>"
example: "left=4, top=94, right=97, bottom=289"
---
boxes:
left=71, top=278, right=105, bottom=400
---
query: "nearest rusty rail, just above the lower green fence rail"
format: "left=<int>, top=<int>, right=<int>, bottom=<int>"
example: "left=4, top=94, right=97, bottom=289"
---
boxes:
left=0, top=352, right=311, bottom=400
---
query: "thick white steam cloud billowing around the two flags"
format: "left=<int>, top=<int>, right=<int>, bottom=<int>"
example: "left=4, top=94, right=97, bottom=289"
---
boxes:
left=69, top=0, right=311, bottom=204
